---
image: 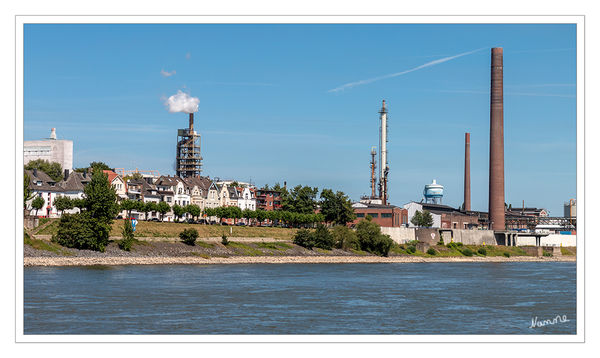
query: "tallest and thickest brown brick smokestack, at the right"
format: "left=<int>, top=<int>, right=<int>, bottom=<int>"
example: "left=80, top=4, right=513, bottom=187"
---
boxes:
left=489, top=47, right=505, bottom=230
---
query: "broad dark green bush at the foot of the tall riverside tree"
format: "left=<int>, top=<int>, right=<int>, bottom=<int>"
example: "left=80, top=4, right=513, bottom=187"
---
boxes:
left=52, top=211, right=110, bottom=252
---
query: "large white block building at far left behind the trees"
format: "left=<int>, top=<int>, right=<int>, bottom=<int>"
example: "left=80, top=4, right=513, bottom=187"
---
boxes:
left=23, top=128, right=73, bottom=173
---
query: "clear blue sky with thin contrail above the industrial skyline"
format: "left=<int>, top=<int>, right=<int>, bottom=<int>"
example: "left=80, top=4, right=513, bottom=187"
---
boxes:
left=24, top=24, right=577, bottom=216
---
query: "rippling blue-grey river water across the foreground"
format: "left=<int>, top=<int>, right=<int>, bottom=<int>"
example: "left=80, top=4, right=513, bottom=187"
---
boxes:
left=24, top=262, right=576, bottom=334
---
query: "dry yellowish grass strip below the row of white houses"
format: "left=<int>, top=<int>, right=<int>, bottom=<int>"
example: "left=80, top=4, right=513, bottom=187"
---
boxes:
left=36, top=219, right=296, bottom=240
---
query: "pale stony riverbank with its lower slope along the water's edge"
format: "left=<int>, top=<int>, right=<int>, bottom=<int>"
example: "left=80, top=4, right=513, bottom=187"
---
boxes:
left=23, top=238, right=576, bottom=266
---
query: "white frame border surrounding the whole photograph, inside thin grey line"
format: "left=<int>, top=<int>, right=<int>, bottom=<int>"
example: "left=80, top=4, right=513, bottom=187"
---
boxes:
left=15, top=15, right=585, bottom=343
